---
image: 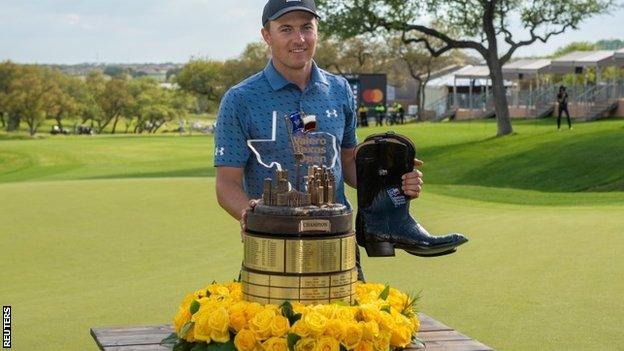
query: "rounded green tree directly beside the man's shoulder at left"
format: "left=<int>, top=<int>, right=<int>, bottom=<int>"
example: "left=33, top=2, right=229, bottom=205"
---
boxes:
left=174, top=59, right=225, bottom=113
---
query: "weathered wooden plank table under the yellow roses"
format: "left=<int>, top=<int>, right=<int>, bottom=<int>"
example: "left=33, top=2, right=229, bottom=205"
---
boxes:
left=91, top=313, right=492, bottom=351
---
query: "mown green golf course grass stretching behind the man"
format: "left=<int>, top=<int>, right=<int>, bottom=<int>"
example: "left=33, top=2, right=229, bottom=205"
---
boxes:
left=0, top=119, right=624, bottom=350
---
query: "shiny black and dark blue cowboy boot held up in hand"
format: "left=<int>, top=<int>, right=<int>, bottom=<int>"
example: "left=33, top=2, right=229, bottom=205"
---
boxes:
left=356, top=133, right=468, bottom=257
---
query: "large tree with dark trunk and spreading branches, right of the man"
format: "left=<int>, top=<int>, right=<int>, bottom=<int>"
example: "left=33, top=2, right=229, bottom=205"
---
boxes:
left=317, top=0, right=614, bottom=135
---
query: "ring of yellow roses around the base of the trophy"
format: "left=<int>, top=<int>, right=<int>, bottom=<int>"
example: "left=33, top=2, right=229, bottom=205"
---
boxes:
left=161, top=282, right=422, bottom=351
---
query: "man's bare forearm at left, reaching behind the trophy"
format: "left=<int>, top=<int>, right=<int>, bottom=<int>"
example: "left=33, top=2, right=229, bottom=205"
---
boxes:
left=216, top=166, right=250, bottom=220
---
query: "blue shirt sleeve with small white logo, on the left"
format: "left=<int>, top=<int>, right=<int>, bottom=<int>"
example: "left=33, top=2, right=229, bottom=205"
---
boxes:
left=214, top=90, right=250, bottom=167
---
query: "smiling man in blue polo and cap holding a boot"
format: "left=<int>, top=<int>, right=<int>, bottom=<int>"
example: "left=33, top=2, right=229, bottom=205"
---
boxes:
left=215, top=0, right=422, bottom=280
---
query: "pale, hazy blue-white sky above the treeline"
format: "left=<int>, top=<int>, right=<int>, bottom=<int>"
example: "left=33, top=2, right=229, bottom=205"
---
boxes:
left=0, top=0, right=624, bottom=64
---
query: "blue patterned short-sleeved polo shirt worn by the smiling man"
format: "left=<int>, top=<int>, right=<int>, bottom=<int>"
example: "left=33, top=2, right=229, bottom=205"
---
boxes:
left=214, top=61, right=357, bottom=206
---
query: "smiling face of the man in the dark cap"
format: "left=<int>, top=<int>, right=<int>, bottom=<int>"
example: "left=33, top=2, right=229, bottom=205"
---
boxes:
left=262, top=11, right=318, bottom=70
